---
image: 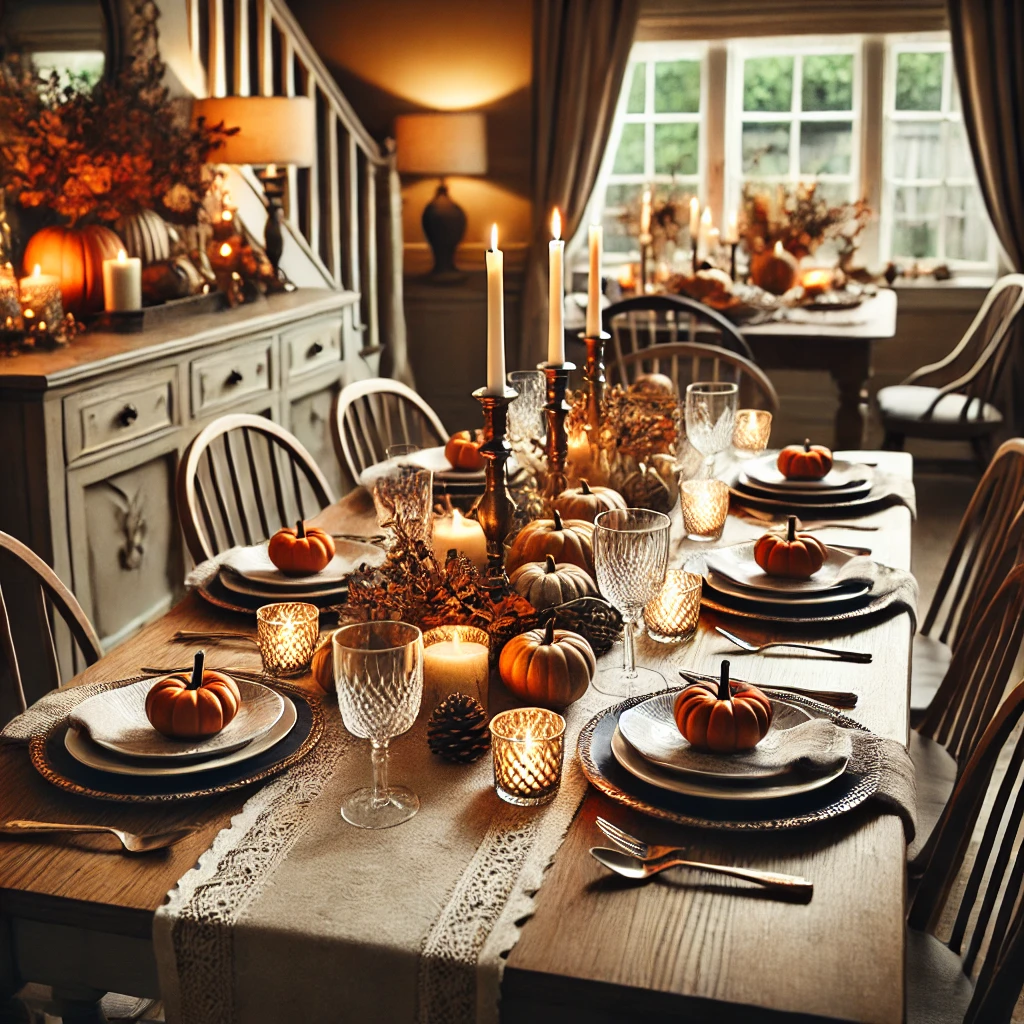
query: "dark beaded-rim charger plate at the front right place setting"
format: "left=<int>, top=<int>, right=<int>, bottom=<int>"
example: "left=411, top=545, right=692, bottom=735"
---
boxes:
left=578, top=688, right=882, bottom=831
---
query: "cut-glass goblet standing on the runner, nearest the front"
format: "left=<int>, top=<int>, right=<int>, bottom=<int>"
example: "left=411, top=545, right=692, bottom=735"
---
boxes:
left=332, top=622, right=423, bottom=828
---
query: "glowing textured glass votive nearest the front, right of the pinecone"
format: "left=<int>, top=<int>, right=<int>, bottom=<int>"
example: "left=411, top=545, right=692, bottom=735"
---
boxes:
left=490, top=708, right=565, bottom=807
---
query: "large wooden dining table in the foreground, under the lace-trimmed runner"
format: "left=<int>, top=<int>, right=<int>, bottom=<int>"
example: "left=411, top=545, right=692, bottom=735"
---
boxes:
left=0, top=453, right=911, bottom=1024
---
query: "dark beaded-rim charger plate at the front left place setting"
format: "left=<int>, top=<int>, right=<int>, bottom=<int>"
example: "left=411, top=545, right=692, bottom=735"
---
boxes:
left=29, top=684, right=324, bottom=804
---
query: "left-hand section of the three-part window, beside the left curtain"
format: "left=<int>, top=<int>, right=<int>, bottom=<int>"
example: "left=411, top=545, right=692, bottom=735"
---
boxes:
left=602, top=43, right=703, bottom=262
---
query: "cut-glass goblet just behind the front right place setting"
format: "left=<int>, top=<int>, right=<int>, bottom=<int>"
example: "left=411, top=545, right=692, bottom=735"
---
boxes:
left=594, top=509, right=671, bottom=697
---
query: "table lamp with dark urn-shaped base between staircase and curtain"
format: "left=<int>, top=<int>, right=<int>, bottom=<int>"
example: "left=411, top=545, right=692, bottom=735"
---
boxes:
left=394, top=113, right=487, bottom=284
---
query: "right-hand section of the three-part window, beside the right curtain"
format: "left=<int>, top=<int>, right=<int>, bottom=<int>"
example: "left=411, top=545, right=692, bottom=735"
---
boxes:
left=883, top=42, right=995, bottom=266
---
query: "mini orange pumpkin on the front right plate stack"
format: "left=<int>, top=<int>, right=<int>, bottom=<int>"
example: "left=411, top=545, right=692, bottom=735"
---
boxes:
left=674, top=662, right=772, bottom=754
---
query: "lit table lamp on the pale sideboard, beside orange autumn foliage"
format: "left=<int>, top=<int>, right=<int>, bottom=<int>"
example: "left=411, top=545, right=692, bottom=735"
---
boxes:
left=193, top=96, right=316, bottom=272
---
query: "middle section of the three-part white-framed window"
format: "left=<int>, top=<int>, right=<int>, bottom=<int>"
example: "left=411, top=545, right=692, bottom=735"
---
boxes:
left=727, top=40, right=860, bottom=202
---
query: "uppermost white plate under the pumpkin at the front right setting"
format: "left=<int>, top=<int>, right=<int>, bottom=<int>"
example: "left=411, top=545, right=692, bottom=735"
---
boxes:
left=618, top=691, right=811, bottom=783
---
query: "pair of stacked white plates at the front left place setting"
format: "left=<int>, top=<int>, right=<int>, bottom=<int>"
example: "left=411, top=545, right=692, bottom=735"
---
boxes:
left=63, top=678, right=298, bottom=790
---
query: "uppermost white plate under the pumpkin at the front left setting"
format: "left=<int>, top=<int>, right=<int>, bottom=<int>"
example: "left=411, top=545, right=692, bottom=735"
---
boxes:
left=70, top=676, right=285, bottom=763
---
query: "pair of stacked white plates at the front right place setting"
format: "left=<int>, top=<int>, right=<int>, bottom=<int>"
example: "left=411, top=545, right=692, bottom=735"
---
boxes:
left=611, top=691, right=849, bottom=802
